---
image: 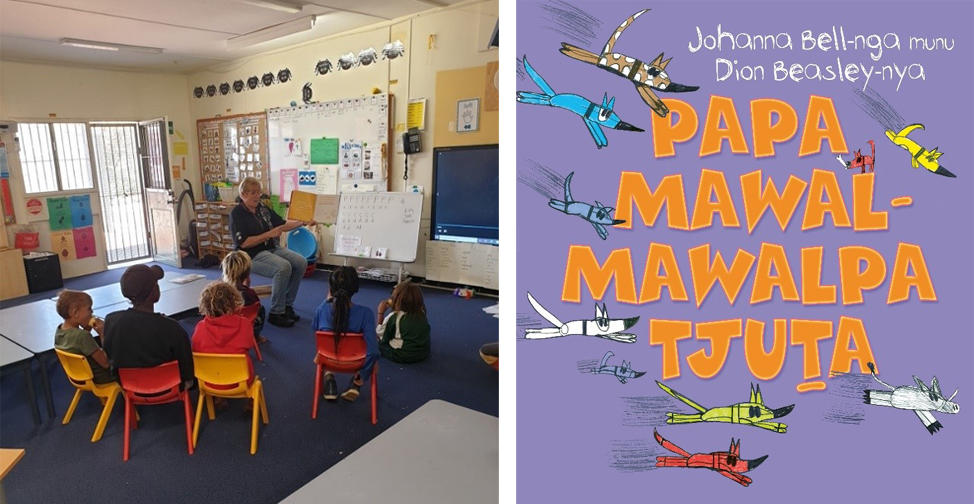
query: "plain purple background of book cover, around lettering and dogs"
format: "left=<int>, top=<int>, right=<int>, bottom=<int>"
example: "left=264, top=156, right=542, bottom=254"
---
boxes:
left=510, top=1, right=974, bottom=502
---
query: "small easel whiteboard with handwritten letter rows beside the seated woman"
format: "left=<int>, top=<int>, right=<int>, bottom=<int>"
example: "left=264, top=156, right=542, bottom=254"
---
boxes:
left=333, top=192, right=423, bottom=262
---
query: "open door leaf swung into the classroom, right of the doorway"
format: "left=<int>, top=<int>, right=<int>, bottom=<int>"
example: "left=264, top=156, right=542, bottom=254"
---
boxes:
left=139, top=118, right=182, bottom=268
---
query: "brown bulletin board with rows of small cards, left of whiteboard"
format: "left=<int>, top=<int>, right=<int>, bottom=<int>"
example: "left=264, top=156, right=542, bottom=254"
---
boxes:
left=196, top=112, right=270, bottom=200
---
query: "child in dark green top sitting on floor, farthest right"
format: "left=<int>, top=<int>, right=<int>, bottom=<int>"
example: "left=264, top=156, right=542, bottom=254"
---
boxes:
left=375, top=280, right=430, bottom=364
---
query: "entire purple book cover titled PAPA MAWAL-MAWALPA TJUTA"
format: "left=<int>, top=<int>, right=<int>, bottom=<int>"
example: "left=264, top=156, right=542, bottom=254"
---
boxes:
left=515, top=1, right=974, bottom=502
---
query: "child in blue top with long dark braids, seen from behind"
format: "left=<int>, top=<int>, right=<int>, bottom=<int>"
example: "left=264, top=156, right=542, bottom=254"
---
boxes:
left=311, top=266, right=379, bottom=401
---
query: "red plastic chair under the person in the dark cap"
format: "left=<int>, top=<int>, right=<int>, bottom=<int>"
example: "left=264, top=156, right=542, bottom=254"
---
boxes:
left=118, top=361, right=193, bottom=461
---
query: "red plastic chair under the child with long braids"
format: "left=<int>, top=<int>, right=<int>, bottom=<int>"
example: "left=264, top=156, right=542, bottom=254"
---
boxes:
left=311, top=331, right=379, bottom=425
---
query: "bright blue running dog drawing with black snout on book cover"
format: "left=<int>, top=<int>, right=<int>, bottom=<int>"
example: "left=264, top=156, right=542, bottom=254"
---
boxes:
left=517, top=56, right=644, bottom=149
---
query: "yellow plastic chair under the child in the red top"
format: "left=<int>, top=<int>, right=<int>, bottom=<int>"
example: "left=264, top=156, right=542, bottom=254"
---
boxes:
left=193, top=352, right=267, bottom=455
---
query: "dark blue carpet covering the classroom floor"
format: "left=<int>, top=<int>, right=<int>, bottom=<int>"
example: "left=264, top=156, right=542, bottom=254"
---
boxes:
left=0, top=266, right=498, bottom=503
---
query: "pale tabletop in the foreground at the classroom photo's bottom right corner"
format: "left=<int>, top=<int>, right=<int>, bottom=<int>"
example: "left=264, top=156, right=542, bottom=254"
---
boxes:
left=282, top=400, right=499, bottom=504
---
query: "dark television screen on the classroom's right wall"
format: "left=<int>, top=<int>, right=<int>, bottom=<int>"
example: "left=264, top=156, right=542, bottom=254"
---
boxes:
left=430, top=145, right=500, bottom=245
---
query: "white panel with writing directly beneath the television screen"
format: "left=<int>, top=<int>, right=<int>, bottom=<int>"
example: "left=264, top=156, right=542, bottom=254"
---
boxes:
left=426, top=240, right=500, bottom=290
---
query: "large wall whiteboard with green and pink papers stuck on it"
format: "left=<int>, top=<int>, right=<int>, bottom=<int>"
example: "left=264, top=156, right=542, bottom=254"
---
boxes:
left=267, top=94, right=392, bottom=202
